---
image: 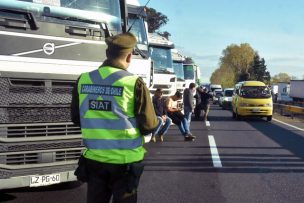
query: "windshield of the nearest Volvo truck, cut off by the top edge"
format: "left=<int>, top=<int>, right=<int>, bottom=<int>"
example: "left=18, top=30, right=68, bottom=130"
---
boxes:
left=0, top=0, right=121, bottom=32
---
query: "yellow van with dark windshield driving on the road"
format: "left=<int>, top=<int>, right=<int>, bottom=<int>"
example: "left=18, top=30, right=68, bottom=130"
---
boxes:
left=232, top=81, right=273, bottom=121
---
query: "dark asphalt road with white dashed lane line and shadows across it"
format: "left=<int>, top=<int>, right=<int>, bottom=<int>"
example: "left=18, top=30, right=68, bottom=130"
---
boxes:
left=0, top=106, right=304, bottom=203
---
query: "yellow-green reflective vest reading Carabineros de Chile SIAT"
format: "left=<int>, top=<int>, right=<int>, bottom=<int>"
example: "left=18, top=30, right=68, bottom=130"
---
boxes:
left=78, top=66, right=146, bottom=164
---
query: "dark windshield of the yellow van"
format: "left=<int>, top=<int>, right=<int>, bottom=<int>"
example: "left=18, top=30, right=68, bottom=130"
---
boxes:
left=240, top=86, right=271, bottom=98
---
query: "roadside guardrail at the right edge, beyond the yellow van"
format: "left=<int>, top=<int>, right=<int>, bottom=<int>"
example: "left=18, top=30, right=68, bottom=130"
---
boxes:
left=273, top=103, right=304, bottom=119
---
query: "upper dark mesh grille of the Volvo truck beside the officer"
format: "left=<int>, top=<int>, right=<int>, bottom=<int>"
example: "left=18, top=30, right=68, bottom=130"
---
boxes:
left=0, top=78, right=75, bottom=124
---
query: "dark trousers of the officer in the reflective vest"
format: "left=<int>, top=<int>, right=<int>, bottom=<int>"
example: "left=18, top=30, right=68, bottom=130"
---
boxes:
left=87, top=160, right=139, bottom=203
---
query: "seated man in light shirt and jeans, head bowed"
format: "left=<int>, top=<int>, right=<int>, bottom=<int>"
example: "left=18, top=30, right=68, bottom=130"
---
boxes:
left=166, top=91, right=195, bottom=141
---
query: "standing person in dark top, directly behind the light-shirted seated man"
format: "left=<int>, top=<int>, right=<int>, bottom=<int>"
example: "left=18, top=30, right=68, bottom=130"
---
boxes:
left=183, top=83, right=196, bottom=128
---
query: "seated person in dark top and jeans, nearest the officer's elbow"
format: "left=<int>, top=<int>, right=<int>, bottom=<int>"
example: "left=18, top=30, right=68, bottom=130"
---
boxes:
left=151, top=89, right=172, bottom=142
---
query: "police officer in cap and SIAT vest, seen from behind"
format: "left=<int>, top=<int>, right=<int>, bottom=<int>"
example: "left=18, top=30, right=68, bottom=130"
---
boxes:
left=72, top=33, right=158, bottom=202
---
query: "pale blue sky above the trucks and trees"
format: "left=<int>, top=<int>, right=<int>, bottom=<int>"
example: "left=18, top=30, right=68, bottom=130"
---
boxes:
left=140, top=0, right=304, bottom=82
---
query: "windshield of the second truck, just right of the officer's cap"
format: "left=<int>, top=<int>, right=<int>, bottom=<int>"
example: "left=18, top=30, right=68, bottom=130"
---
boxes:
left=128, top=15, right=148, bottom=54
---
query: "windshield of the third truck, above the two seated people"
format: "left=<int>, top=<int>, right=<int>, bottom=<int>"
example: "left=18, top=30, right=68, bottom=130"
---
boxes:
left=149, top=47, right=174, bottom=73
